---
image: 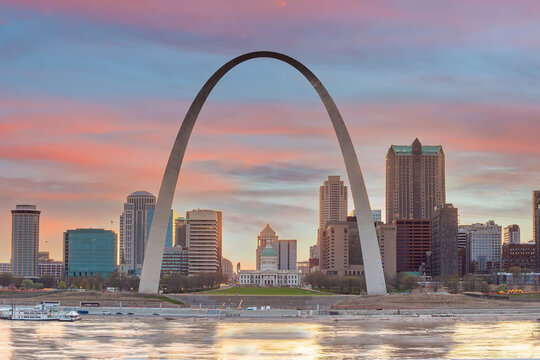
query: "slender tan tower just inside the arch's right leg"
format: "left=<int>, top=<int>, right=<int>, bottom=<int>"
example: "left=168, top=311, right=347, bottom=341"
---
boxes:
left=319, top=176, right=348, bottom=228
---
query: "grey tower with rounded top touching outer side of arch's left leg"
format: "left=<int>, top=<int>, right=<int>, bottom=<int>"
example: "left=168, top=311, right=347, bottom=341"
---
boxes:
left=120, top=191, right=156, bottom=273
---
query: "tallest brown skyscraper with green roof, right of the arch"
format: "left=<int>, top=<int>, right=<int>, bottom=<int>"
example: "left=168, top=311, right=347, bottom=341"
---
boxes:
left=386, top=139, right=446, bottom=224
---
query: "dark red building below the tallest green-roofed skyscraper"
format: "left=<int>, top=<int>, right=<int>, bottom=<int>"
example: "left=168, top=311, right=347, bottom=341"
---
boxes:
left=393, top=219, right=431, bottom=273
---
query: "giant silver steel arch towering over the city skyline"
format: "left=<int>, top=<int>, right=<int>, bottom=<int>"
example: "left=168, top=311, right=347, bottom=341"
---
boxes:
left=139, top=51, right=386, bottom=295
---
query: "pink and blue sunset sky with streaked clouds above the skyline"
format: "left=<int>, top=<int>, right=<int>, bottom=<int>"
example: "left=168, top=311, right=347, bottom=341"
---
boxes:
left=0, top=0, right=540, bottom=268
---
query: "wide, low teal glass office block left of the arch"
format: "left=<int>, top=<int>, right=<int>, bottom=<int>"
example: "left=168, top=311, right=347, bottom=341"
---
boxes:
left=64, top=229, right=117, bottom=277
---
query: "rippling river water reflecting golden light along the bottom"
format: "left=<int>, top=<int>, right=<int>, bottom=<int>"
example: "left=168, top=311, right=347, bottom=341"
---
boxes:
left=0, top=316, right=540, bottom=360
